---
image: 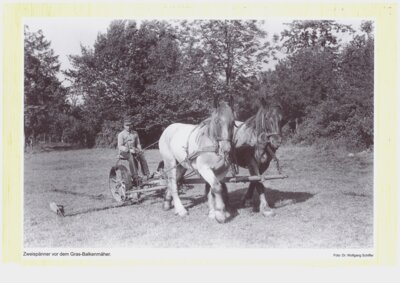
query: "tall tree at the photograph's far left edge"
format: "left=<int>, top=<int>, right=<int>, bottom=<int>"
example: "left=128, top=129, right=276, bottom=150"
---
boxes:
left=24, top=26, right=67, bottom=142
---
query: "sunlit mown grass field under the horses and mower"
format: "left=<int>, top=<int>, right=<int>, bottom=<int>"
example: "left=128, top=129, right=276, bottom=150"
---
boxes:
left=24, top=146, right=373, bottom=248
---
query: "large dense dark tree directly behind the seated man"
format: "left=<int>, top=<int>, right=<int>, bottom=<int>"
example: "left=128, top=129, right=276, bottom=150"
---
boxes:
left=66, top=21, right=184, bottom=146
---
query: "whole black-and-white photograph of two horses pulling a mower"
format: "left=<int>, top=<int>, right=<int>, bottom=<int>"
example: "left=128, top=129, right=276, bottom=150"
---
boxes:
left=21, top=17, right=376, bottom=251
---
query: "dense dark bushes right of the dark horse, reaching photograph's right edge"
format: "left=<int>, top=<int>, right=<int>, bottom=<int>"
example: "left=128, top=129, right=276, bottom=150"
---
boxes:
left=270, top=22, right=374, bottom=149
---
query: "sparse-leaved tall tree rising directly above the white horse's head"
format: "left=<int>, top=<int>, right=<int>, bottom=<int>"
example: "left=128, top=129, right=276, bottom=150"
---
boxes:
left=180, top=20, right=272, bottom=105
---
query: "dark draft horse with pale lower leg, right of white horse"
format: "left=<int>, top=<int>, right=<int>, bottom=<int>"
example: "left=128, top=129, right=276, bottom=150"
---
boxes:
left=206, top=99, right=283, bottom=216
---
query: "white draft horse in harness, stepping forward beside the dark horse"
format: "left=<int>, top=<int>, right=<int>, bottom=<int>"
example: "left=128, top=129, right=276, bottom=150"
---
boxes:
left=159, top=99, right=235, bottom=223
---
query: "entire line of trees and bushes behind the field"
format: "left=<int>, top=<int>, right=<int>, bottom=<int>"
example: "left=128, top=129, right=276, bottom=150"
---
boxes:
left=24, top=20, right=374, bottom=149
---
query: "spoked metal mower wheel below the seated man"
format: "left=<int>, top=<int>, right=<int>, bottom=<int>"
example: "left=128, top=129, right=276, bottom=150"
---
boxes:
left=108, top=165, right=132, bottom=203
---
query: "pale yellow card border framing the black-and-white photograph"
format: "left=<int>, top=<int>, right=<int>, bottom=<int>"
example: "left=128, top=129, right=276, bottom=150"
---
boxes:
left=2, top=3, right=399, bottom=266
